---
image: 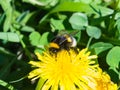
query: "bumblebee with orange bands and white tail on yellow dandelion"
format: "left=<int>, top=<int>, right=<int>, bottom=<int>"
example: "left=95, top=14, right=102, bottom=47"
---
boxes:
left=49, top=30, right=77, bottom=53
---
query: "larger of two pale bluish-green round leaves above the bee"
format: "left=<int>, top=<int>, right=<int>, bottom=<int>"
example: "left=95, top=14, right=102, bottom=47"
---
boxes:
left=69, top=13, right=88, bottom=30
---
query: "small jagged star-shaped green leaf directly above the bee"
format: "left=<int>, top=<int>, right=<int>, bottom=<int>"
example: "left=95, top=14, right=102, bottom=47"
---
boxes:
left=50, top=18, right=65, bottom=30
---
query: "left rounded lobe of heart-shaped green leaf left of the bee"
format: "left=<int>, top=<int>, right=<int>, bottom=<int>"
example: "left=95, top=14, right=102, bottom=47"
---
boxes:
left=29, top=31, right=41, bottom=46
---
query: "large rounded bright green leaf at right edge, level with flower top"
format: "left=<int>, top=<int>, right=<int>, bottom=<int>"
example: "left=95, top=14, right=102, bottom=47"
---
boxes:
left=106, top=46, right=120, bottom=68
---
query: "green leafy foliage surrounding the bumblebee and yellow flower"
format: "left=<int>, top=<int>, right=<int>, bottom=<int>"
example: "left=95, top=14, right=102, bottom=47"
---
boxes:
left=0, top=0, right=120, bottom=90
